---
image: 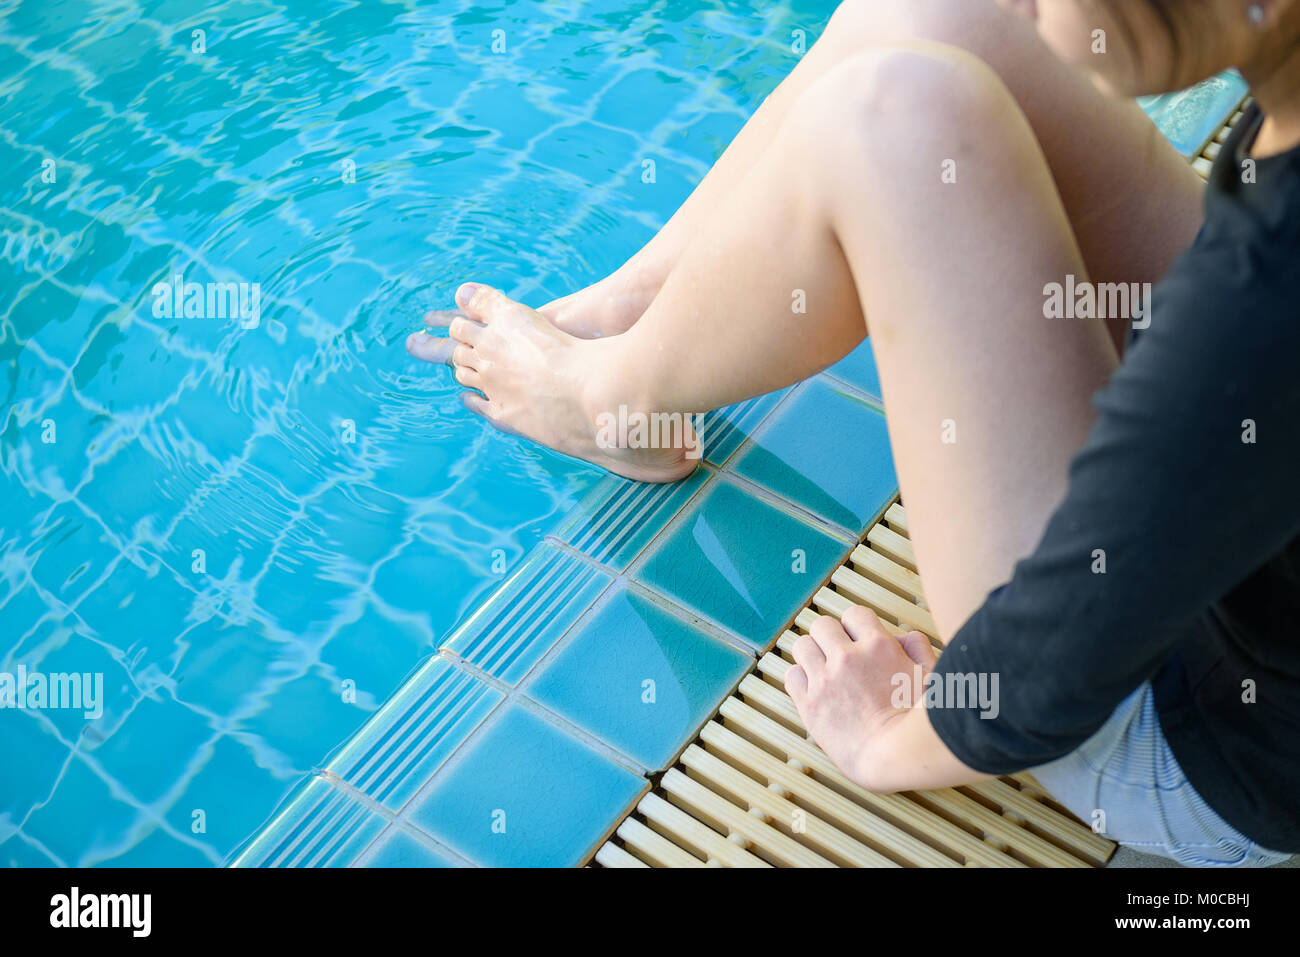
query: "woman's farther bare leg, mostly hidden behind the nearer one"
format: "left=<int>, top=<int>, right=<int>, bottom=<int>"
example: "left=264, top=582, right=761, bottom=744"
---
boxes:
left=542, top=0, right=1200, bottom=345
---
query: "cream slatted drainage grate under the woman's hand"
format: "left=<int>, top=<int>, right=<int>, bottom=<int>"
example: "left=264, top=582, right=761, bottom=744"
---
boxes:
left=592, top=503, right=1114, bottom=867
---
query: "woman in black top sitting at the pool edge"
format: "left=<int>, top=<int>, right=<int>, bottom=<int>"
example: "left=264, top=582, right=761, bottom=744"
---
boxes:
left=408, top=0, right=1300, bottom=866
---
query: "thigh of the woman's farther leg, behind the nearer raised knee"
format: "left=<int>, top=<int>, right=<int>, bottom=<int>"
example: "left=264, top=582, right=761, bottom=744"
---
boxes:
left=823, top=0, right=1204, bottom=347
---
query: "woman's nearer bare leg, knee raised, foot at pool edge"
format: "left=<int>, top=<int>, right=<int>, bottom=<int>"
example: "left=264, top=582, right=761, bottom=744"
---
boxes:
left=452, top=48, right=1118, bottom=637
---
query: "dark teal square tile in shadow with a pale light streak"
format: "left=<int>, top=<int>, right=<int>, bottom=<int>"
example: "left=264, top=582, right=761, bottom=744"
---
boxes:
left=633, top=482, right=852, bottom=649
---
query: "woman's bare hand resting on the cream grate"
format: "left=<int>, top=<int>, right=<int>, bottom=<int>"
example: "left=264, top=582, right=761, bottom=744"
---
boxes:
left=785, top=605, right=936, bottom=789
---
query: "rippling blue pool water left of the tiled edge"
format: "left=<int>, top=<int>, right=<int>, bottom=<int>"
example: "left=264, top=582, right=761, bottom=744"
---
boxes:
left=0, top=0, right=833, bottom=866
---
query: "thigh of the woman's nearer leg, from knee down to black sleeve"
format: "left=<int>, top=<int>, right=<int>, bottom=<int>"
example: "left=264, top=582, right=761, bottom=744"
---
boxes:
left=829, top=47, right=1118, bottom=640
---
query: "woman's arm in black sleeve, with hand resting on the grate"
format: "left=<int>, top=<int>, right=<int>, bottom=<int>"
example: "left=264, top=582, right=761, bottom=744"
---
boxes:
left=785, top=263, right=1300, bottom=791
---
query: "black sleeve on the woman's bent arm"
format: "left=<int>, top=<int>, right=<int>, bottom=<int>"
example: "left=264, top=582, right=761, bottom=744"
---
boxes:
left=930, top=250, right=1300, bottom=774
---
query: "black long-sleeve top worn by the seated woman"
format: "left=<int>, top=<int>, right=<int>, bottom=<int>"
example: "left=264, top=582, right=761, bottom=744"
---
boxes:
left=930, top=108, right=1300, bottom=852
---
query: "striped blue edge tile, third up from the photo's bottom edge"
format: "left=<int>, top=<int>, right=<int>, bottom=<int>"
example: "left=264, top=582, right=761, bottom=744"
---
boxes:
left=442, top=545, right=610, bottom=684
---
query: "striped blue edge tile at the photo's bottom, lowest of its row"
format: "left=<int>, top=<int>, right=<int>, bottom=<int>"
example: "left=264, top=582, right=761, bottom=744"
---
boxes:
left=234, top=775, right=389, bottom=867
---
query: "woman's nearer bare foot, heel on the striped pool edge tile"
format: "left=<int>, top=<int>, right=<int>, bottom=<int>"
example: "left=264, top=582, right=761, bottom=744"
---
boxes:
left=407, top=283, right=699, bottom=482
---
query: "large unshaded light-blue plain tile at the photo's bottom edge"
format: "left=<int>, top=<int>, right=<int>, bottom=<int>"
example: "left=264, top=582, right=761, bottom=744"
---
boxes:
left=406, top=705, right=647, bottom=867
